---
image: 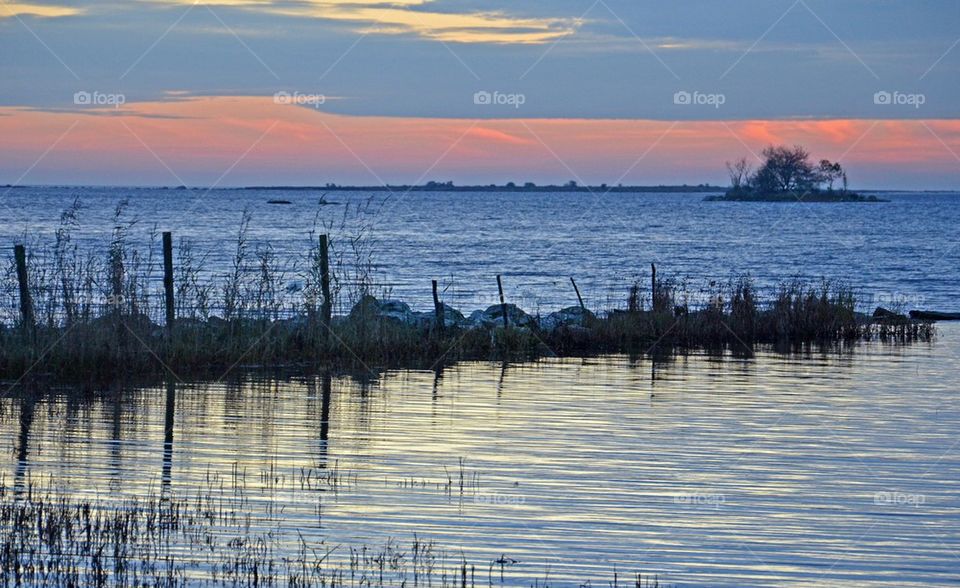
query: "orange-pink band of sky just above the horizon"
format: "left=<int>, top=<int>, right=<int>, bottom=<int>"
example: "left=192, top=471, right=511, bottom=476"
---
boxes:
left=0, top=97, right=960, bottom=188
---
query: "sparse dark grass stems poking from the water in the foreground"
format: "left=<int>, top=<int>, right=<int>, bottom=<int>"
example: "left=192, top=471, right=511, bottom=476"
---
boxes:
left=0, top=474, right=661, bottom=588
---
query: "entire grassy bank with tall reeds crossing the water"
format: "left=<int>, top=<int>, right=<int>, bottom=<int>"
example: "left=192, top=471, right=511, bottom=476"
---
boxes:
left=0, top=201, right=934, bottom=380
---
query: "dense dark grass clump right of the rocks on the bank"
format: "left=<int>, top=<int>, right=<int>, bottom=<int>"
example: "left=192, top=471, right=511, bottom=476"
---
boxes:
left=542, top=277, right=934, bottom=354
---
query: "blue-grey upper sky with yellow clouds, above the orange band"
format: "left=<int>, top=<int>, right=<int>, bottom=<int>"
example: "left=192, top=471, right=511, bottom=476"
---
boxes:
left=0, top=0, right=960, bottom=120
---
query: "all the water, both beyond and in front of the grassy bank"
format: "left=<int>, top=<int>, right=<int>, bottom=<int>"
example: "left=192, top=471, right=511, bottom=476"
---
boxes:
left=0, top=188, right=960, bottom=586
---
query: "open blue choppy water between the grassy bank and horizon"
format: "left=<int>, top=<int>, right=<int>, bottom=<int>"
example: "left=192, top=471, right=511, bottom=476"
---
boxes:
left=0, top=188, right=960, bottom=312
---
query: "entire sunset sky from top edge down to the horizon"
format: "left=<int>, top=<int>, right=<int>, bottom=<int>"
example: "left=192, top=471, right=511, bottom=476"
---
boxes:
left=0, top=0, right=960, bottom=189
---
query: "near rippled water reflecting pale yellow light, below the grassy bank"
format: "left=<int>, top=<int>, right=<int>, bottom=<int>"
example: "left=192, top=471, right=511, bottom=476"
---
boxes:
left=0, top=327, right=960, bottom=586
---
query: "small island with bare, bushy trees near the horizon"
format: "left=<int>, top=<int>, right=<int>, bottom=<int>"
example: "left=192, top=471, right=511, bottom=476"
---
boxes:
left=706, top=145, right=886, bottom=202
